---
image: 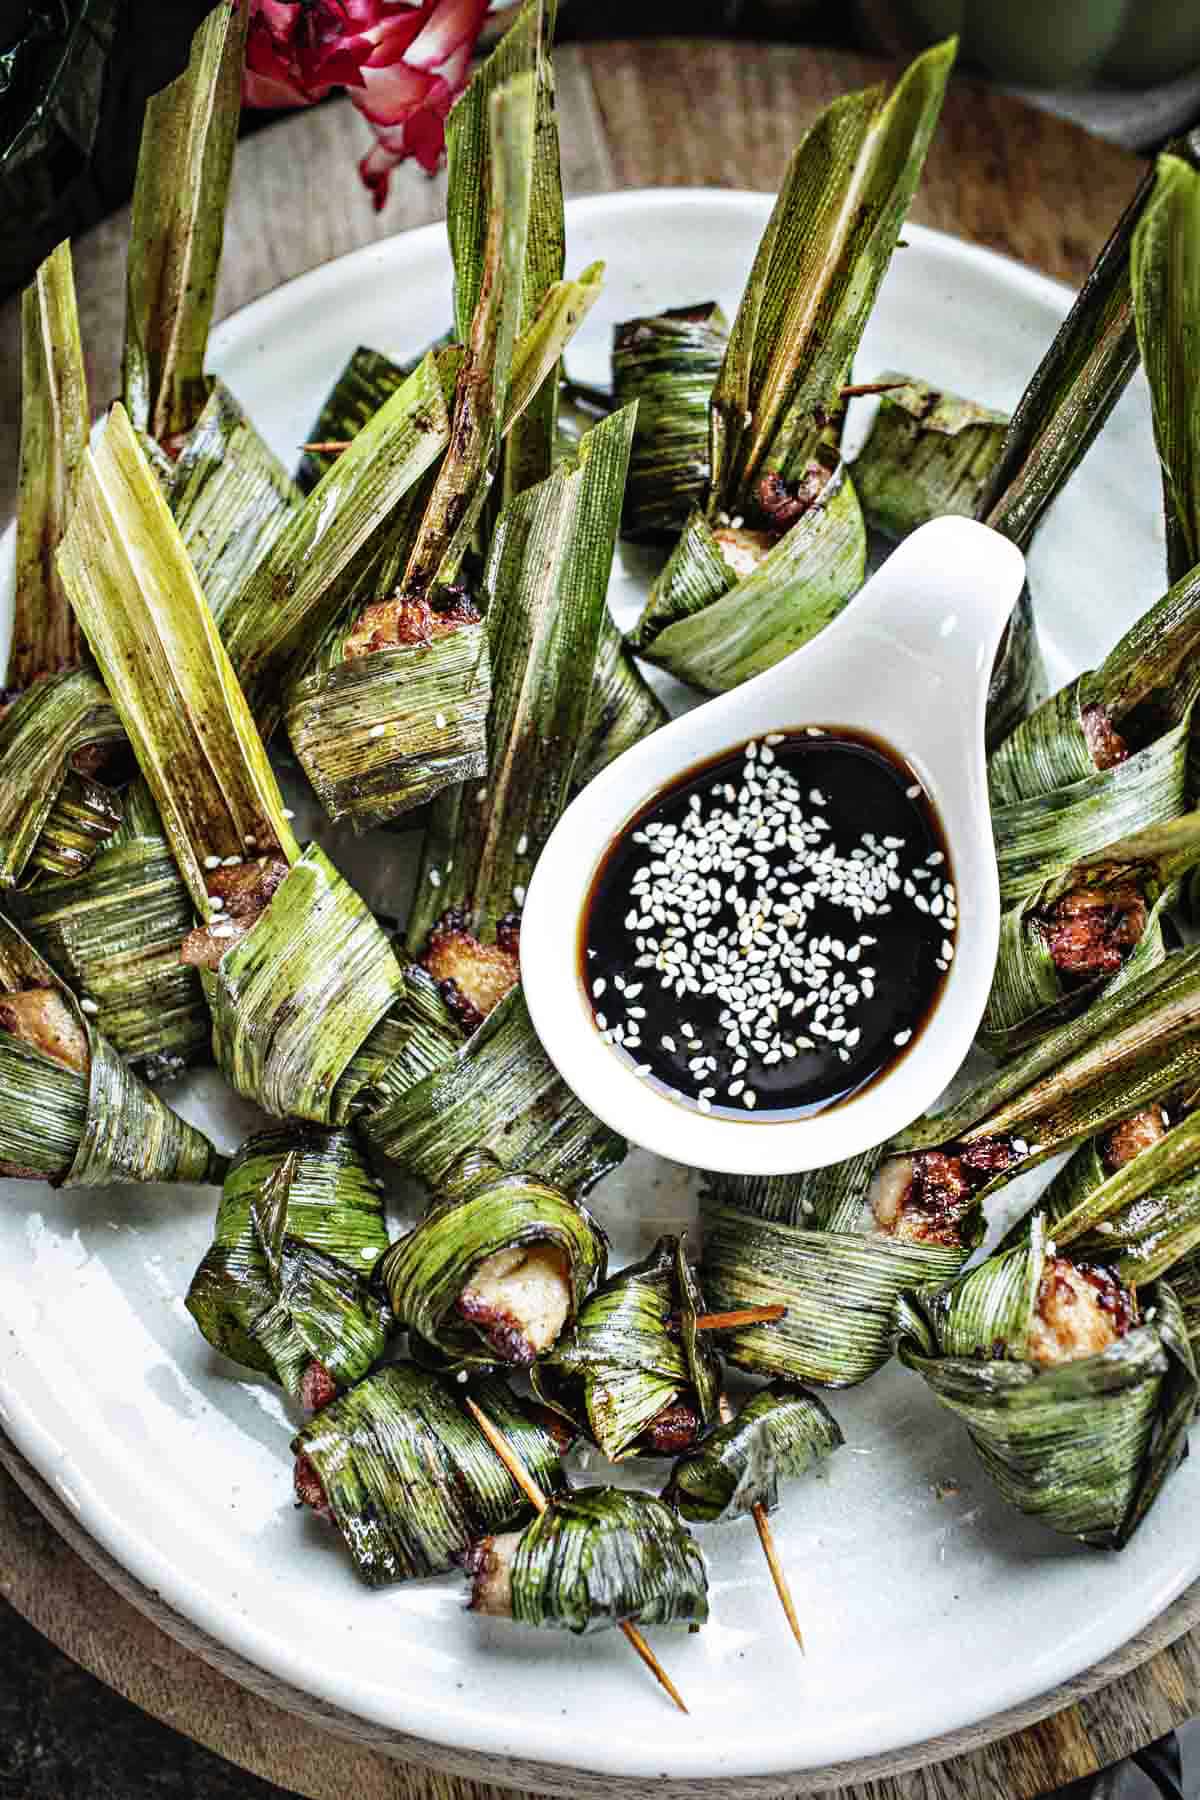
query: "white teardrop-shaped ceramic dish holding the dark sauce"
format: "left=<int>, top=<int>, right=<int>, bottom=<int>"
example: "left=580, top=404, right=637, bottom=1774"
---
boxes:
left=522, top=518, right=1025, bottom=1175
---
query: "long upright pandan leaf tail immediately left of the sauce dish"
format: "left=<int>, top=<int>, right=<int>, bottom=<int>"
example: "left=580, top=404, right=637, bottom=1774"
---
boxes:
left=408, top=409, right=633, bottom=950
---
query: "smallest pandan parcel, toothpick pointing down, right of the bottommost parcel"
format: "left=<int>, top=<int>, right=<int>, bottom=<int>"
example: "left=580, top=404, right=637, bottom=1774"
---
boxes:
left=662, top=1382, right=846, bottom=1525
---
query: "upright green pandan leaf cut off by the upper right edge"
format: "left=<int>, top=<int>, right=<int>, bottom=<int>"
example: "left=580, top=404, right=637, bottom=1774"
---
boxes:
left=1130, top=146, right=1200, bottom=581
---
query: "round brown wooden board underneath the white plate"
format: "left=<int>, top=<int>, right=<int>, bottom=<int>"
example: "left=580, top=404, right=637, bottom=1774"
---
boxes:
left=0, top=40, right=1200, bottom=1800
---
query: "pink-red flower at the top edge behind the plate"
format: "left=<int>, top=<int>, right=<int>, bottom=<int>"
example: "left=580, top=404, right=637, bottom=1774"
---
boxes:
left=241, top=0, right=488, bottom=212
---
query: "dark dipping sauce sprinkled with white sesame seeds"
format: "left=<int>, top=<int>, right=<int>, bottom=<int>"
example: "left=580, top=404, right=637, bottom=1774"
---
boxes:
left=581, top=725, right=957, bottom=1120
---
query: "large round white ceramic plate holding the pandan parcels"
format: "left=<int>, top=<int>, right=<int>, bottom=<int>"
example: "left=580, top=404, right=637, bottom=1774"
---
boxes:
left=0, top=193, right=1180, bottom=1786
